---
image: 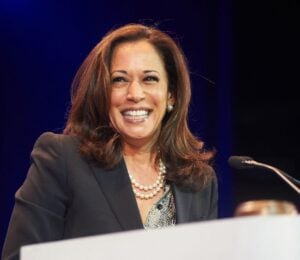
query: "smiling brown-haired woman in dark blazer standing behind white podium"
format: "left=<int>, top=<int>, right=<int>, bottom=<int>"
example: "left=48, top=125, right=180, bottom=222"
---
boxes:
left=3, top=24, right=217, bottom=259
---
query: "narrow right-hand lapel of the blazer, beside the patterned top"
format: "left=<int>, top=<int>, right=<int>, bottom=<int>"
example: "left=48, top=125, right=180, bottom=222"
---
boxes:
left=172, top=184, right=193, bottom=224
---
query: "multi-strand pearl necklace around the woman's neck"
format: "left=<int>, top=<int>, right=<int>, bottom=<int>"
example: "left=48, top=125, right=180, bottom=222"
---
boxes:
left=129, top=160, right=166, bottom=199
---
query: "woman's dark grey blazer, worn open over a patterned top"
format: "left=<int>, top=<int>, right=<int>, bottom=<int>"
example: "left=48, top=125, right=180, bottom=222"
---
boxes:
left=2, top=132, right=217, bottom=260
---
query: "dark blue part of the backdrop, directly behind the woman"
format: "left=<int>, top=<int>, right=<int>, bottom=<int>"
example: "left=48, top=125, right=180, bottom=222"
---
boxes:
left=0, top=0, right=232, bottom=249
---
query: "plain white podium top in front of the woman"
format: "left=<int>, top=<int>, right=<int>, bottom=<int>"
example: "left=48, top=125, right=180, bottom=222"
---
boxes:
left=21, top=215, right=300, bottom=260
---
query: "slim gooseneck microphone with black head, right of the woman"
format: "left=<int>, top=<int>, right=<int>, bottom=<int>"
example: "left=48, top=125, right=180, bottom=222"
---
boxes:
left=228, top=156, right=300, bottom=194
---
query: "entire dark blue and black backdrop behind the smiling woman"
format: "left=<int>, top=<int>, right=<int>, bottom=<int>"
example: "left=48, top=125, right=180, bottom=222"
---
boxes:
left=0, top=0, right=300, bottom=252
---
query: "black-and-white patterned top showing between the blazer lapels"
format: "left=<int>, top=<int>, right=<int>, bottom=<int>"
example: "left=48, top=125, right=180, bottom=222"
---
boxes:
left=144, top=185, right=176, bottom=229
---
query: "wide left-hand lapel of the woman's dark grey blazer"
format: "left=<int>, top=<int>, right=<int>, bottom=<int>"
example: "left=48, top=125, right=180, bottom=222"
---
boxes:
left=93, top=160, right=143, bottom=230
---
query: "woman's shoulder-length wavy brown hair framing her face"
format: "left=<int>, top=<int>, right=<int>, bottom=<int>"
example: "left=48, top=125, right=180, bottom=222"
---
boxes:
left=64, top=24, right=214, bottom=190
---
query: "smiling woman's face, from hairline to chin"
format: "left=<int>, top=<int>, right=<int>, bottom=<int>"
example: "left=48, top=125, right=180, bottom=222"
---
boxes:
left=109, top=40, right=173, bottom=145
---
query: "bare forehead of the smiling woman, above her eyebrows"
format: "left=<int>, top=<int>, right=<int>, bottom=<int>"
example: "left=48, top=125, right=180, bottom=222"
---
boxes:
left=111, top=40, right=165, bottom=69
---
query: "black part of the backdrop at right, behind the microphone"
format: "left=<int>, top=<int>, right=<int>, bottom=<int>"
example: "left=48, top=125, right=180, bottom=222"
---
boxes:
left=232, top=1, right=300, bottom=209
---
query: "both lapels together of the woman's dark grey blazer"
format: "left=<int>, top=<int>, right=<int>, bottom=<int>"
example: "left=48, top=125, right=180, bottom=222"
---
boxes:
left=93, top=159, right=193, bottom=230
